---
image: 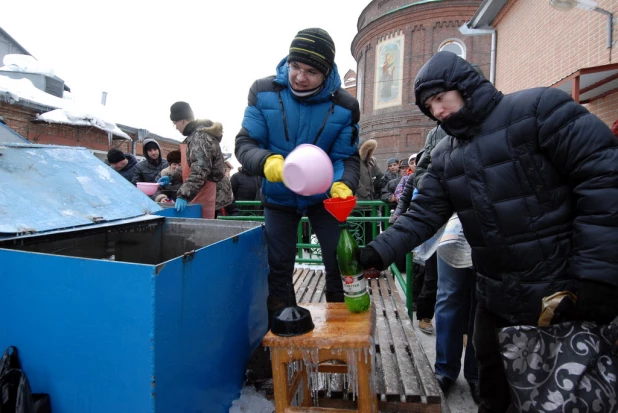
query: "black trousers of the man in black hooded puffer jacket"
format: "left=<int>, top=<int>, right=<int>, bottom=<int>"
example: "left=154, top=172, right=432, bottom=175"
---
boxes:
left=474, top=302, right=513, bottom=413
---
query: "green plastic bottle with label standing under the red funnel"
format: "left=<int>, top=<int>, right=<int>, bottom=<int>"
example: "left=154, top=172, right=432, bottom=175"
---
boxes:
left=337, top=223, right=371, bottom=313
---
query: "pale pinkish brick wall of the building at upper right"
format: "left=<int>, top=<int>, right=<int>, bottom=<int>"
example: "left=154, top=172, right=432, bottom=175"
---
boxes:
left=493, top=0, right=618, bottom=125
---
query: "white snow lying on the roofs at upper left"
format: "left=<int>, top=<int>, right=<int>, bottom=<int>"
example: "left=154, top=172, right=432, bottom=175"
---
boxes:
left=0, top=55, right=131, bottom=140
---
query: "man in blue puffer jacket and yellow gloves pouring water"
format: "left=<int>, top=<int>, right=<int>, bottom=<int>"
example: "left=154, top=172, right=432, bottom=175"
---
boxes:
left=236, top=28, right=360, bottom=322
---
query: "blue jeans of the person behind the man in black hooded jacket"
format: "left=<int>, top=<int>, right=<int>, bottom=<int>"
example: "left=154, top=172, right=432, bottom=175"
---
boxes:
left=435, top=256, right=479, bottom=383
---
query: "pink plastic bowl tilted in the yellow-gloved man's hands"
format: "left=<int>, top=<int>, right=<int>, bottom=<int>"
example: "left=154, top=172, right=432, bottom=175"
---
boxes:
left=283, top=143, right=334, bottom=196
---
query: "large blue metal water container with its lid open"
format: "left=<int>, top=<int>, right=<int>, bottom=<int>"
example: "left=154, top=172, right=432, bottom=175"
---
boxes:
left=0, top=145, right=267, bottom=413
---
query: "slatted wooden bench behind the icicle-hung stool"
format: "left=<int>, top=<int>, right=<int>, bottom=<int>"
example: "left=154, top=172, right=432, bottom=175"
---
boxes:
left=294, top=267, right=448, bottom=412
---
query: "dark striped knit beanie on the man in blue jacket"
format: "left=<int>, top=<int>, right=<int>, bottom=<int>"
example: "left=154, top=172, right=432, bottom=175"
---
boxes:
left=288, top=28, right=335, bottom=76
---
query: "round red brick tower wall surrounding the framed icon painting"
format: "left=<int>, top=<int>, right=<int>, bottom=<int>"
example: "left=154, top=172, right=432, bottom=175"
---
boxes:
left=352, top=0, right=484, bottom=165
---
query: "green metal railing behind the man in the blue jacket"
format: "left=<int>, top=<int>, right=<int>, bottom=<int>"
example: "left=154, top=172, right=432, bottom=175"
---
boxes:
left=218, top=201, right=412, bottom=318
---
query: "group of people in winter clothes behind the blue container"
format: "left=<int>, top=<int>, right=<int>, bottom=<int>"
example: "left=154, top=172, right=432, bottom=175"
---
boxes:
left=107, top=102, right=248, bottom=219
